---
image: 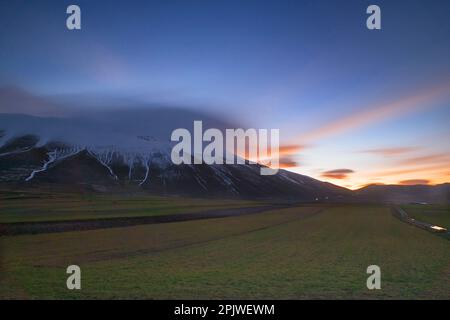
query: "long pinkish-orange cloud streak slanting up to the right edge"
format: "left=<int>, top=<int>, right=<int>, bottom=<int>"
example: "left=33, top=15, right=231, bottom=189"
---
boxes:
left=299, top=83, right=450, bottom=141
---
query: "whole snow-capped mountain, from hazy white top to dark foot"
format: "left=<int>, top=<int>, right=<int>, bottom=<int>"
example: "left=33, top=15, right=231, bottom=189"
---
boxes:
left=0, top=110, right=351, bottom=201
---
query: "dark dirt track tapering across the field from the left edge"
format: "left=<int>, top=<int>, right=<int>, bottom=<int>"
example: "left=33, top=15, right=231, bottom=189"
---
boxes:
left=0, top=205, right=288, bottom=236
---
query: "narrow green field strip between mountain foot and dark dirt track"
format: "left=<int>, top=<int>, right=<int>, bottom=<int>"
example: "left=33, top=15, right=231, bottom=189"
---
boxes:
left=0, top=192, right=261, bottom=223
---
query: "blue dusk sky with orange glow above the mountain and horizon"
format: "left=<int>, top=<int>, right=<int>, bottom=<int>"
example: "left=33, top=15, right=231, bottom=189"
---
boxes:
left=0, top=0, right=450, bottom=189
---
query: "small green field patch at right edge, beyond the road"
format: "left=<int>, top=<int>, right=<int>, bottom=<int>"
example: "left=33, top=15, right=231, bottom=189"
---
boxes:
left=403, top=204, right=450, bottom=230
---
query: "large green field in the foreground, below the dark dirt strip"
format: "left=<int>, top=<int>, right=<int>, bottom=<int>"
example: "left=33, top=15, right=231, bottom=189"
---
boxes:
left=0, top=205, right=450, bottom=299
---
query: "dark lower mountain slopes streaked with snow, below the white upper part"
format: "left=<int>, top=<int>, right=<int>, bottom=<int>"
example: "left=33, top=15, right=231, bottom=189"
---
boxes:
left=0, top=132, right=349, bottom=201
